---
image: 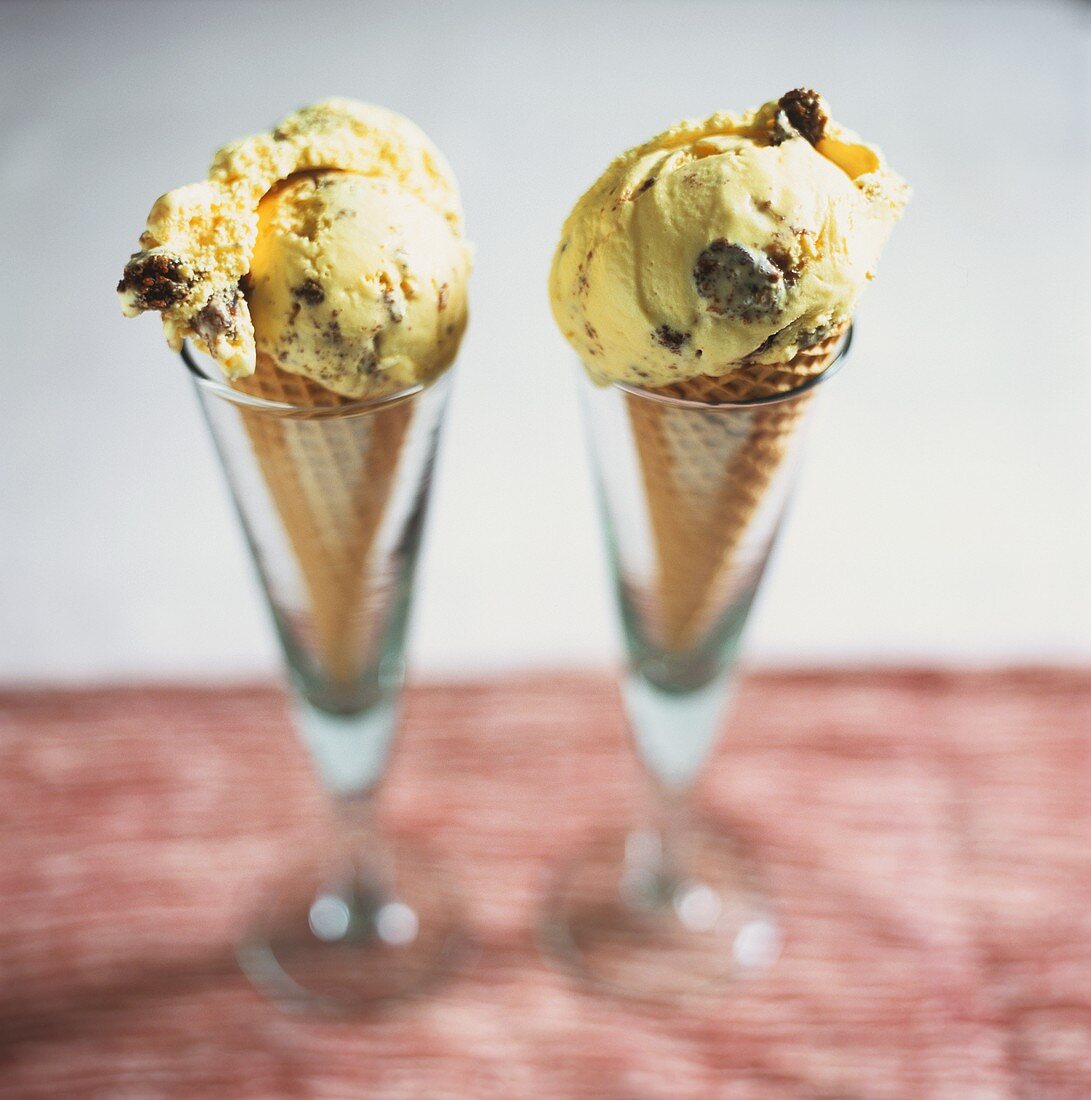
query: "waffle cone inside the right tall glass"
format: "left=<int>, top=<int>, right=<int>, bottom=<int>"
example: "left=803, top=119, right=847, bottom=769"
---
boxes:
left=627, top=330, right=844, bottom=651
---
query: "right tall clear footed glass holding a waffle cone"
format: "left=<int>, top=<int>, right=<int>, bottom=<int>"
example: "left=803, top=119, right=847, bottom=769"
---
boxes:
left=541, top=325, right=851, bottom=998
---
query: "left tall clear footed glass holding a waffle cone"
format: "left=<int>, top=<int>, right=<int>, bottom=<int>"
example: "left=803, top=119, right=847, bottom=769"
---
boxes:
left=183, top=349, right=462, bottom=1012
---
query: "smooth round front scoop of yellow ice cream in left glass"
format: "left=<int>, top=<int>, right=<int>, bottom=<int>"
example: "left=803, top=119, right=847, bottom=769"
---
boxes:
left=244, top=172, right=470, bottom=397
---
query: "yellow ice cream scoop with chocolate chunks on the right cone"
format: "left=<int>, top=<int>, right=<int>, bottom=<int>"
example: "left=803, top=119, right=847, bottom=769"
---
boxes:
left=550, top=89, right=908, bottom=386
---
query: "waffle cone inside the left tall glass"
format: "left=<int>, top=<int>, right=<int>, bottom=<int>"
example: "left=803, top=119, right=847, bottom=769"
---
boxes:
left=232, top=355, right=411, bottom=684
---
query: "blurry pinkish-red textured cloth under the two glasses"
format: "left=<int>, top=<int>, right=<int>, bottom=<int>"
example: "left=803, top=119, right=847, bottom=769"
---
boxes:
left=0, top=671, right=1091, bottom=1100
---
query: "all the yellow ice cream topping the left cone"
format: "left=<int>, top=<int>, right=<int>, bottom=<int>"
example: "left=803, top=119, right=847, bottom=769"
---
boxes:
left=118, top=99, right=471, bottom=397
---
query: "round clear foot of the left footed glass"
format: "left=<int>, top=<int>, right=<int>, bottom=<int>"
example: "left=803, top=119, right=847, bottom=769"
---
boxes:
left=238, top=838, right=470, bottom=1015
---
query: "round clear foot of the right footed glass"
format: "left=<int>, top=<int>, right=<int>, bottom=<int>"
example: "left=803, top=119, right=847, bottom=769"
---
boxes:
left=540, top=826, right=781, bottom=1001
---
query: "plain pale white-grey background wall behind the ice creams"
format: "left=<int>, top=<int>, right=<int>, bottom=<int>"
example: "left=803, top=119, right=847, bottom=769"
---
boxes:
left=0, top=0, right=1091, bottom=680
